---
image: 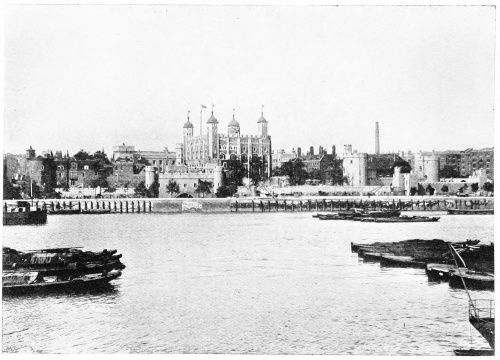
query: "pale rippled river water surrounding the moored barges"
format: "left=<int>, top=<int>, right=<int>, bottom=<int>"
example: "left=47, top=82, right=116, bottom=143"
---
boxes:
left=2, top=212, right=494, bottom=355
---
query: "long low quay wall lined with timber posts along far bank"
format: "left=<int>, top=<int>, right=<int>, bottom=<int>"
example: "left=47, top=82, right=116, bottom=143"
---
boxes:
left=4, top=196, right=494, bottom=213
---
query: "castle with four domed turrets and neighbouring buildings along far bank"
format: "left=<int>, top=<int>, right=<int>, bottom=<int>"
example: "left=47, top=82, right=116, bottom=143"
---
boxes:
left=4, top=109, right=494, bottom=197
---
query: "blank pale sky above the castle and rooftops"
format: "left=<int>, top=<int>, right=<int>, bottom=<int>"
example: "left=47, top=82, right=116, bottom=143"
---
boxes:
left=4, top=5, right=495, bottom=154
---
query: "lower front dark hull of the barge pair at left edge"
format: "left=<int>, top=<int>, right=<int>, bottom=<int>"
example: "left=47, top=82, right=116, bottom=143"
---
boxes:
left=2, top=271, right=122, bottom=295
